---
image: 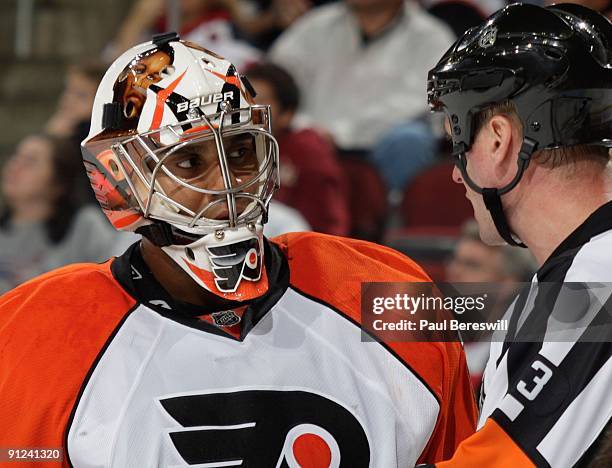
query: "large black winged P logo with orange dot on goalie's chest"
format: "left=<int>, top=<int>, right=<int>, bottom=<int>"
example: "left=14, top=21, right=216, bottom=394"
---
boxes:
left=160, top=390, right=370, bottom=468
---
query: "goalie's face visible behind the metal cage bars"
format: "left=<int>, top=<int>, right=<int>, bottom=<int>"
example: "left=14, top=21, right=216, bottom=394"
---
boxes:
left=148, top=133, right=261, bottom=220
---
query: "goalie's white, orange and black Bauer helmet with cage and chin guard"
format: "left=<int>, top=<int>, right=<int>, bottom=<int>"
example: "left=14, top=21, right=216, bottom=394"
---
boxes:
left=81, top=33, right=279, bottom=301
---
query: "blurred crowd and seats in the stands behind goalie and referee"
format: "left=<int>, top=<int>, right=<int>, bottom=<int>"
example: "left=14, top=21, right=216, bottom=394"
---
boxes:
left=0, top=0, right=612, bottom=383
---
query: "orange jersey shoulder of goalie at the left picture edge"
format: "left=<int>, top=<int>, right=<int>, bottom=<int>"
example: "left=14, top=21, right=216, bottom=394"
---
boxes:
left=0, top=260, right=135, bottom=458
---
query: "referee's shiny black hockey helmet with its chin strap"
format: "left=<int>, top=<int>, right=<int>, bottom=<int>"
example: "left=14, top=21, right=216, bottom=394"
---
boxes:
left=427, top=4, right=612, bottom=245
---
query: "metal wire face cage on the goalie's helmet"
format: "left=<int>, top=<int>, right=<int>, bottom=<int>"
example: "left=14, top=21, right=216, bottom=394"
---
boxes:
left=111, top=102, right=279, bottom=232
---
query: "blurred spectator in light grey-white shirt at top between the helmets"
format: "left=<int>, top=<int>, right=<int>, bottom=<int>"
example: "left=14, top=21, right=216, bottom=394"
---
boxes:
left=270, top=0, right=453, bottom=151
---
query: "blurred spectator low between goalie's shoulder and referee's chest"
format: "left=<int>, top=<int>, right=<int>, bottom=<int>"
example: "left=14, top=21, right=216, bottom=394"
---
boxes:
left=446, top=220, right=537, bottom=390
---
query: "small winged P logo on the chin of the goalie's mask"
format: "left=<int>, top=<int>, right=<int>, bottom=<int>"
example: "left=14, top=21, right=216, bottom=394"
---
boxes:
left=207, top=237, right=261, bottom=292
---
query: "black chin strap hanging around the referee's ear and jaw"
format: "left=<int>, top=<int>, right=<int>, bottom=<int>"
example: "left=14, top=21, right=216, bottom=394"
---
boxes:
left=453, top=137, right=538, bottom=247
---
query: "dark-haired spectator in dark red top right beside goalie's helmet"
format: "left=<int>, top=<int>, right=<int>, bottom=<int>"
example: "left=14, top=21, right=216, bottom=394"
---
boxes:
left=247, top=64, right=350, bottom=235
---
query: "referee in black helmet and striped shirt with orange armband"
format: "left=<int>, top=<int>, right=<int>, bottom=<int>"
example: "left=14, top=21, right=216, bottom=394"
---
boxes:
left=428, top=4, right=612, bottom=468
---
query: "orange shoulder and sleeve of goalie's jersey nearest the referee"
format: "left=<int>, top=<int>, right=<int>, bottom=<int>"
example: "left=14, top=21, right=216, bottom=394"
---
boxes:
left=272, top=233, right=477, bottom=463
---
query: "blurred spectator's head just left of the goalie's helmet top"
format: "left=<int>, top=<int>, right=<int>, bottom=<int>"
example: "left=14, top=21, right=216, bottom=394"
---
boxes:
left=45, top=61, right=107, bottom=145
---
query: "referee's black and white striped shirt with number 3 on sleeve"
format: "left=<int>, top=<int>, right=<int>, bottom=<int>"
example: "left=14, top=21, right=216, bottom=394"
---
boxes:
left=478, top=202, right=612, bottom=467
